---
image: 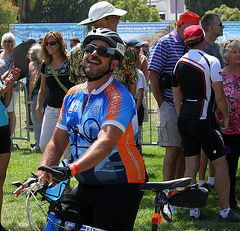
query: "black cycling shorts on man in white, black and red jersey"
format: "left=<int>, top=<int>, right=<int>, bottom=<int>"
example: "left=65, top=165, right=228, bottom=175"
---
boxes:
left=178, top=117, right=225, bottom=161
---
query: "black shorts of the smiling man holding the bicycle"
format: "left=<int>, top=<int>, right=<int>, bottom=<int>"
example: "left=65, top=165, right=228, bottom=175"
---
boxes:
left=71, top=183, right=143, bottom=231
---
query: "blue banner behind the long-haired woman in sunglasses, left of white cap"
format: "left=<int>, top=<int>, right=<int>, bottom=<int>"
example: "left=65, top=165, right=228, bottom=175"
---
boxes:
left=13, top=23, right=85, bottom=51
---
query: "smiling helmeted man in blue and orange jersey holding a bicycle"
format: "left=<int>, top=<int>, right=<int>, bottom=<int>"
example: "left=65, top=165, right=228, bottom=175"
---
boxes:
left=15, top=28, right=146, bottom=231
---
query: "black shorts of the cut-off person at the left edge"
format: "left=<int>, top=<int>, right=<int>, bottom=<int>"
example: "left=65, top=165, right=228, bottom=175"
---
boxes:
left=0, top=124, right=11, bottom=154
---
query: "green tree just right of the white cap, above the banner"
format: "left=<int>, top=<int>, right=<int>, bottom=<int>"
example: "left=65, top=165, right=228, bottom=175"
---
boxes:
left=102, top=0, right=161, bottom=22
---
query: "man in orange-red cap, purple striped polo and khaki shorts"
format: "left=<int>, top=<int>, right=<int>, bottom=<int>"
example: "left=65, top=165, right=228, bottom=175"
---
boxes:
left=148, top=12, right=200, bottom=215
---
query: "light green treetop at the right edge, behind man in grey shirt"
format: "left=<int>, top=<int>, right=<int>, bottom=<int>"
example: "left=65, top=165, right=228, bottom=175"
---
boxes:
left=206, top=4, right=240, bottom=21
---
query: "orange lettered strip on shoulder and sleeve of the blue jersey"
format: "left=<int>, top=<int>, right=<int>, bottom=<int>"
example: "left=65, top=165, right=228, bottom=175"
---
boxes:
left=104, top=81, right=122, bottom=121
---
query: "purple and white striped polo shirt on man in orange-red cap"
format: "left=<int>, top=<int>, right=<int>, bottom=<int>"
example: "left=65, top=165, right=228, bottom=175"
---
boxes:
left=148, top=30, right=188, bottom=105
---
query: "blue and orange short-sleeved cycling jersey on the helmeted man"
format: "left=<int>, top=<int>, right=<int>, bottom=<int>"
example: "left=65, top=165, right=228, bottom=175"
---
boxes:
left=57, top=77, right=145, bottom=185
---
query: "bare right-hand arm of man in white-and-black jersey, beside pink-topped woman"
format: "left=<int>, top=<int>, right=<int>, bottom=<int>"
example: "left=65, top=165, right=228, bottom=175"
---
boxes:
left=212, top=81, right=229, bottom=132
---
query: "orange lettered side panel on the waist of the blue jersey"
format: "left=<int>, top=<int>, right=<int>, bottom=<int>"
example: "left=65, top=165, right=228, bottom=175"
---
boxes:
left=117, top=123, right=145, bottom=183
